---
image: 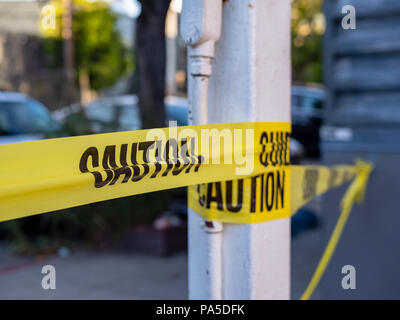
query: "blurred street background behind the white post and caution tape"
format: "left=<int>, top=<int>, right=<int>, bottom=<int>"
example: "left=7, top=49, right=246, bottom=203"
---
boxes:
left=0, top=0, right=400, bottom=299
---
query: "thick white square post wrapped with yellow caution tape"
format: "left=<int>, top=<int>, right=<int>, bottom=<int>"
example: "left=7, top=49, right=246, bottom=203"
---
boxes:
left=184, top=0, right=290, bottom=299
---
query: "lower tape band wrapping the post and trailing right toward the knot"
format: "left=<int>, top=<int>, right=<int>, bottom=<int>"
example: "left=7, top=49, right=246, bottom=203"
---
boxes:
left=188, top=165, right=356, bottom=223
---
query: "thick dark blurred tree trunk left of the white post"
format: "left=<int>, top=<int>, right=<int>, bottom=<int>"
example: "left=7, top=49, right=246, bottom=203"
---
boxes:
left=136, top=0, right=170, bottom=129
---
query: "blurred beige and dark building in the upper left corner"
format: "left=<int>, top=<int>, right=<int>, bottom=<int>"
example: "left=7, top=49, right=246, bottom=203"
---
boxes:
left=0, top=1, right=69, bottom=109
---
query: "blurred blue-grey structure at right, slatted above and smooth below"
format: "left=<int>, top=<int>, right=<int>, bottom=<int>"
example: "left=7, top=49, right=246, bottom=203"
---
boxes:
left=321, top=0, right=400, bottom=299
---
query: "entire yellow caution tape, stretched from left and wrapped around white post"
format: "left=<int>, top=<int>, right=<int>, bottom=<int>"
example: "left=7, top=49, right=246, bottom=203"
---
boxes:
left=0, top=122, right=372, bottom=223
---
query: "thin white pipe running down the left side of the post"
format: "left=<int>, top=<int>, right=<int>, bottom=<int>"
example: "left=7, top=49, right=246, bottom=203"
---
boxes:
left=181, top=0, right=223, bottom=299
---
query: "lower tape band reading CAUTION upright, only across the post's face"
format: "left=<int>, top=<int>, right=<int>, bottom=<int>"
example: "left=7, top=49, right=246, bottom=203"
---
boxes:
left=188, top=166, right=292, bottom=223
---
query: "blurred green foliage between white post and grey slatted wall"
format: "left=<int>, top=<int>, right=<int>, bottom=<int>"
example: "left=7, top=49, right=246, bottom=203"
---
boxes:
left=291, top=0, right=325, bottom=83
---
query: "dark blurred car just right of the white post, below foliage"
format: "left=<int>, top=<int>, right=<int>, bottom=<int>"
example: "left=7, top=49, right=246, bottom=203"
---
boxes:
left=292, top=86, right=325, bottom=158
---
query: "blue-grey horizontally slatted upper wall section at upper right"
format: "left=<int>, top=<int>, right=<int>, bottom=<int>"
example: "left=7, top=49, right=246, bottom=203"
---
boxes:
left=324, top=0, right=400, bottom=126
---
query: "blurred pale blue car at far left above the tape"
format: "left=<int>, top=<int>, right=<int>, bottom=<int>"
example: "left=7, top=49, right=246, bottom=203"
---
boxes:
left=0, top=92, right=59, bottom=144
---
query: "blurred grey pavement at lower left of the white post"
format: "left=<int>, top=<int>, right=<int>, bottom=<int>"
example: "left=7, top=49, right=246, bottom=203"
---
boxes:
left=0, top=248, right=187, bottom=300
